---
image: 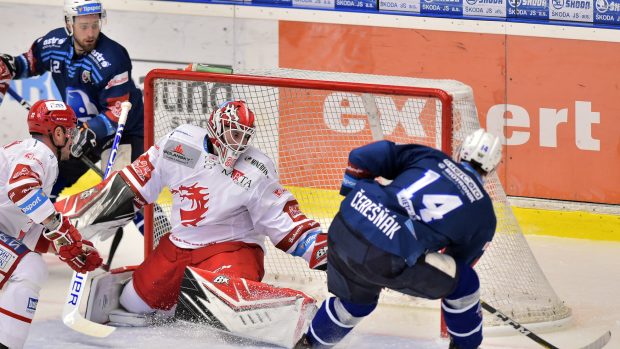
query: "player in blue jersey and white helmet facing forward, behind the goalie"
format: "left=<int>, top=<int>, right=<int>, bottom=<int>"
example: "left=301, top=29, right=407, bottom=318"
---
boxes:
left=0, top=0, right=144, bottom=266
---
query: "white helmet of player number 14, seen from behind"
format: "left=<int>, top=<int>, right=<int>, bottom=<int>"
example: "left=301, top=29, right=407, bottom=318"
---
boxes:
left=459, top=128, right=502, bottom=173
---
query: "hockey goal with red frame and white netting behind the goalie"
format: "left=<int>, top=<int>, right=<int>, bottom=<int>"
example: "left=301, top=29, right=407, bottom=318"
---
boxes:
left=144, top=69, right=570, bottom=326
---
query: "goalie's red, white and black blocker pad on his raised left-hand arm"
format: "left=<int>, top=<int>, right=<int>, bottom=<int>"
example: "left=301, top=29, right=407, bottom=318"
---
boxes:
left=54, top=173, right=135, bottom=240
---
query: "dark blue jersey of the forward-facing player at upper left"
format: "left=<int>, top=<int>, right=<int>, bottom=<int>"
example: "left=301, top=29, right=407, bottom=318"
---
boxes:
left=15, top=28, right=144, bottom=143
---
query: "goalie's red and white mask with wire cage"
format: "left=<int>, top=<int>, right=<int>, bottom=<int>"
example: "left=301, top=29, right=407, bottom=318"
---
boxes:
left=207, top=100, right=256, bottom=171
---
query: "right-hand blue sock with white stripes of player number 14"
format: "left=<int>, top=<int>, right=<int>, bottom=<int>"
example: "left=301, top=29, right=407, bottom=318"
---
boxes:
left=441, top=264, right=482, bottom=349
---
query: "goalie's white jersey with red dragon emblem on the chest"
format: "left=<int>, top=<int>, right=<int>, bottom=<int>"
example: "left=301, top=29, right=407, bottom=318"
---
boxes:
left=121, top=125, right=319, bottom=251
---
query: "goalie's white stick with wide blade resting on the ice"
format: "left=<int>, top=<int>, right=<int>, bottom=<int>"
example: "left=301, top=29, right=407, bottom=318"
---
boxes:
left=62, top=102, right=131, bottom=337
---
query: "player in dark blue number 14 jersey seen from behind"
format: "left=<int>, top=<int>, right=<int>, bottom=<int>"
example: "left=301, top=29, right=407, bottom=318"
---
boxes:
left=297, top=129, right=501, bottom=349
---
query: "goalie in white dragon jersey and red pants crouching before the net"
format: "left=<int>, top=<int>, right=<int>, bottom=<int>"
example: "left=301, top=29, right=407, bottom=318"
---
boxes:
left=65, top=101, right=327, bottom=346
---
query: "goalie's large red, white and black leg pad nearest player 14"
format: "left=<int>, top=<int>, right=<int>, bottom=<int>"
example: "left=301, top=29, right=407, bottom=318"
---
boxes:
left=175, top=267, right=316, bottom=348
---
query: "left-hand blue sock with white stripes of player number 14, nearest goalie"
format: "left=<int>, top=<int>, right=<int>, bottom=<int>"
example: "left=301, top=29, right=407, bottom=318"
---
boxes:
left=306, top=297, right=377, bottom=348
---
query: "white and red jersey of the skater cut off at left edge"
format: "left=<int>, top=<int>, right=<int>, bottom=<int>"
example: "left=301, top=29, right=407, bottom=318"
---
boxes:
left=0, top=138, right=58, bottom=249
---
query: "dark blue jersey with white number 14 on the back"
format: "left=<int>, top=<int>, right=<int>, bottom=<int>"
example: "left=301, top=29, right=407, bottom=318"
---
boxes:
left=340, top=141, right=497, bottom=265
